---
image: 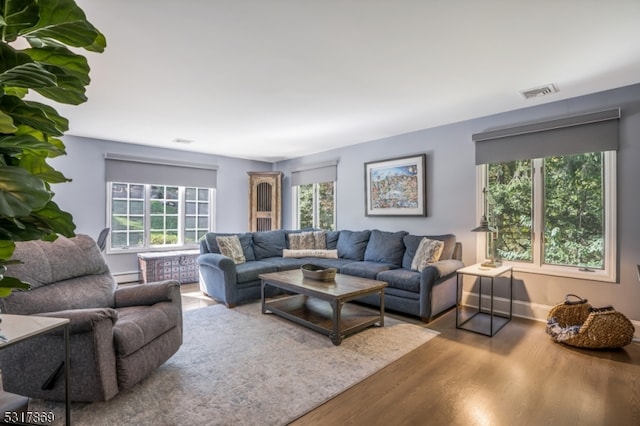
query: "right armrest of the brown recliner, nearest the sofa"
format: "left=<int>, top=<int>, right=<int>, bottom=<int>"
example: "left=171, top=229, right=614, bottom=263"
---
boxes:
left=114, top=280, right=181, bottom=308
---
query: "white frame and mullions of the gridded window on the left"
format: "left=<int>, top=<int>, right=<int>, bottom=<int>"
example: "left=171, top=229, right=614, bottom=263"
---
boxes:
left=105, top=181, right=216, bottom=254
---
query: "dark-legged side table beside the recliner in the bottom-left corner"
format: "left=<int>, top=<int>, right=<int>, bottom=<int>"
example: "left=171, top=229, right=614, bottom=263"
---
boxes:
left=0, top=314, right=71, bottom=426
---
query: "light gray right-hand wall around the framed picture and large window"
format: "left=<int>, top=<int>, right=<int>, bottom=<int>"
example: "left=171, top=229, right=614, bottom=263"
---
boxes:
left=275, top=85, right=640, bottom=320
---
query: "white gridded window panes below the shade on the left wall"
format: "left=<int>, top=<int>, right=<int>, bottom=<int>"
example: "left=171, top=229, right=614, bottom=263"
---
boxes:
left=108, top=182, right=214, bottom=251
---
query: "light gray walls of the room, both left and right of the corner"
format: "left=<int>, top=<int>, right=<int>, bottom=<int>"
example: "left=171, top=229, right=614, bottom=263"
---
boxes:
left=46, top=85, right=640, bottom=320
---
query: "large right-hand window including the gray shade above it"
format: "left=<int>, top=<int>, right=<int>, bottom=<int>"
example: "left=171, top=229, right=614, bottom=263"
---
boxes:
left=473, top=108, right=620, bottom=282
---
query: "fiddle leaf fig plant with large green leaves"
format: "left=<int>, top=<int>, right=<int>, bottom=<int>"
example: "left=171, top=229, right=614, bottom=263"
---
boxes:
left=0, top=0, right=106, bottom=297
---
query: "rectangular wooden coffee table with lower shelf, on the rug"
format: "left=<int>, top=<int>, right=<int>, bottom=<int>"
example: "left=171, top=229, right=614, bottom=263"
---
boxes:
left=259, top=269, right=387, bottom=346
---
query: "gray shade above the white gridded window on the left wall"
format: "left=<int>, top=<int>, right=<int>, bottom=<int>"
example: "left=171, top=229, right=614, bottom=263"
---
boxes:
left=105, top=154, right=217, bottom=188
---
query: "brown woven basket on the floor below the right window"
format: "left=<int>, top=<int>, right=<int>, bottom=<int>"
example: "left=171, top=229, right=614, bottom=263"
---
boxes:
left=547, top=294, right=635, bottom=349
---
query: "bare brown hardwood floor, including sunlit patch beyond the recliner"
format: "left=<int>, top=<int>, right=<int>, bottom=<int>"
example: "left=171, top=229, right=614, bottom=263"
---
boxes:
left=182, top=284, right=640, bottom=426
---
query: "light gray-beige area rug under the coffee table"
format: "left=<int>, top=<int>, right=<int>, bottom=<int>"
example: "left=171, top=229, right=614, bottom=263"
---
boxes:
left=29, top=303, right=438, bottom=426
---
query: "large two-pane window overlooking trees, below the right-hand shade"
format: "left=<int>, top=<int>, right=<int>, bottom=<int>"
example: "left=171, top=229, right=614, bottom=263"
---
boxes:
left=481, top=151, right=616, bottom=281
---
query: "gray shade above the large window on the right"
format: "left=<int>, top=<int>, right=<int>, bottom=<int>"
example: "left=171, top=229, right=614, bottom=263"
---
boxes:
left=472, top=108, right=620, bottom=164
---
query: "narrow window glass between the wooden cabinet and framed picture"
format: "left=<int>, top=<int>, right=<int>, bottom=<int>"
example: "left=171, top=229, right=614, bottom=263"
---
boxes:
left=293, top=182, right=336, bottom=230
